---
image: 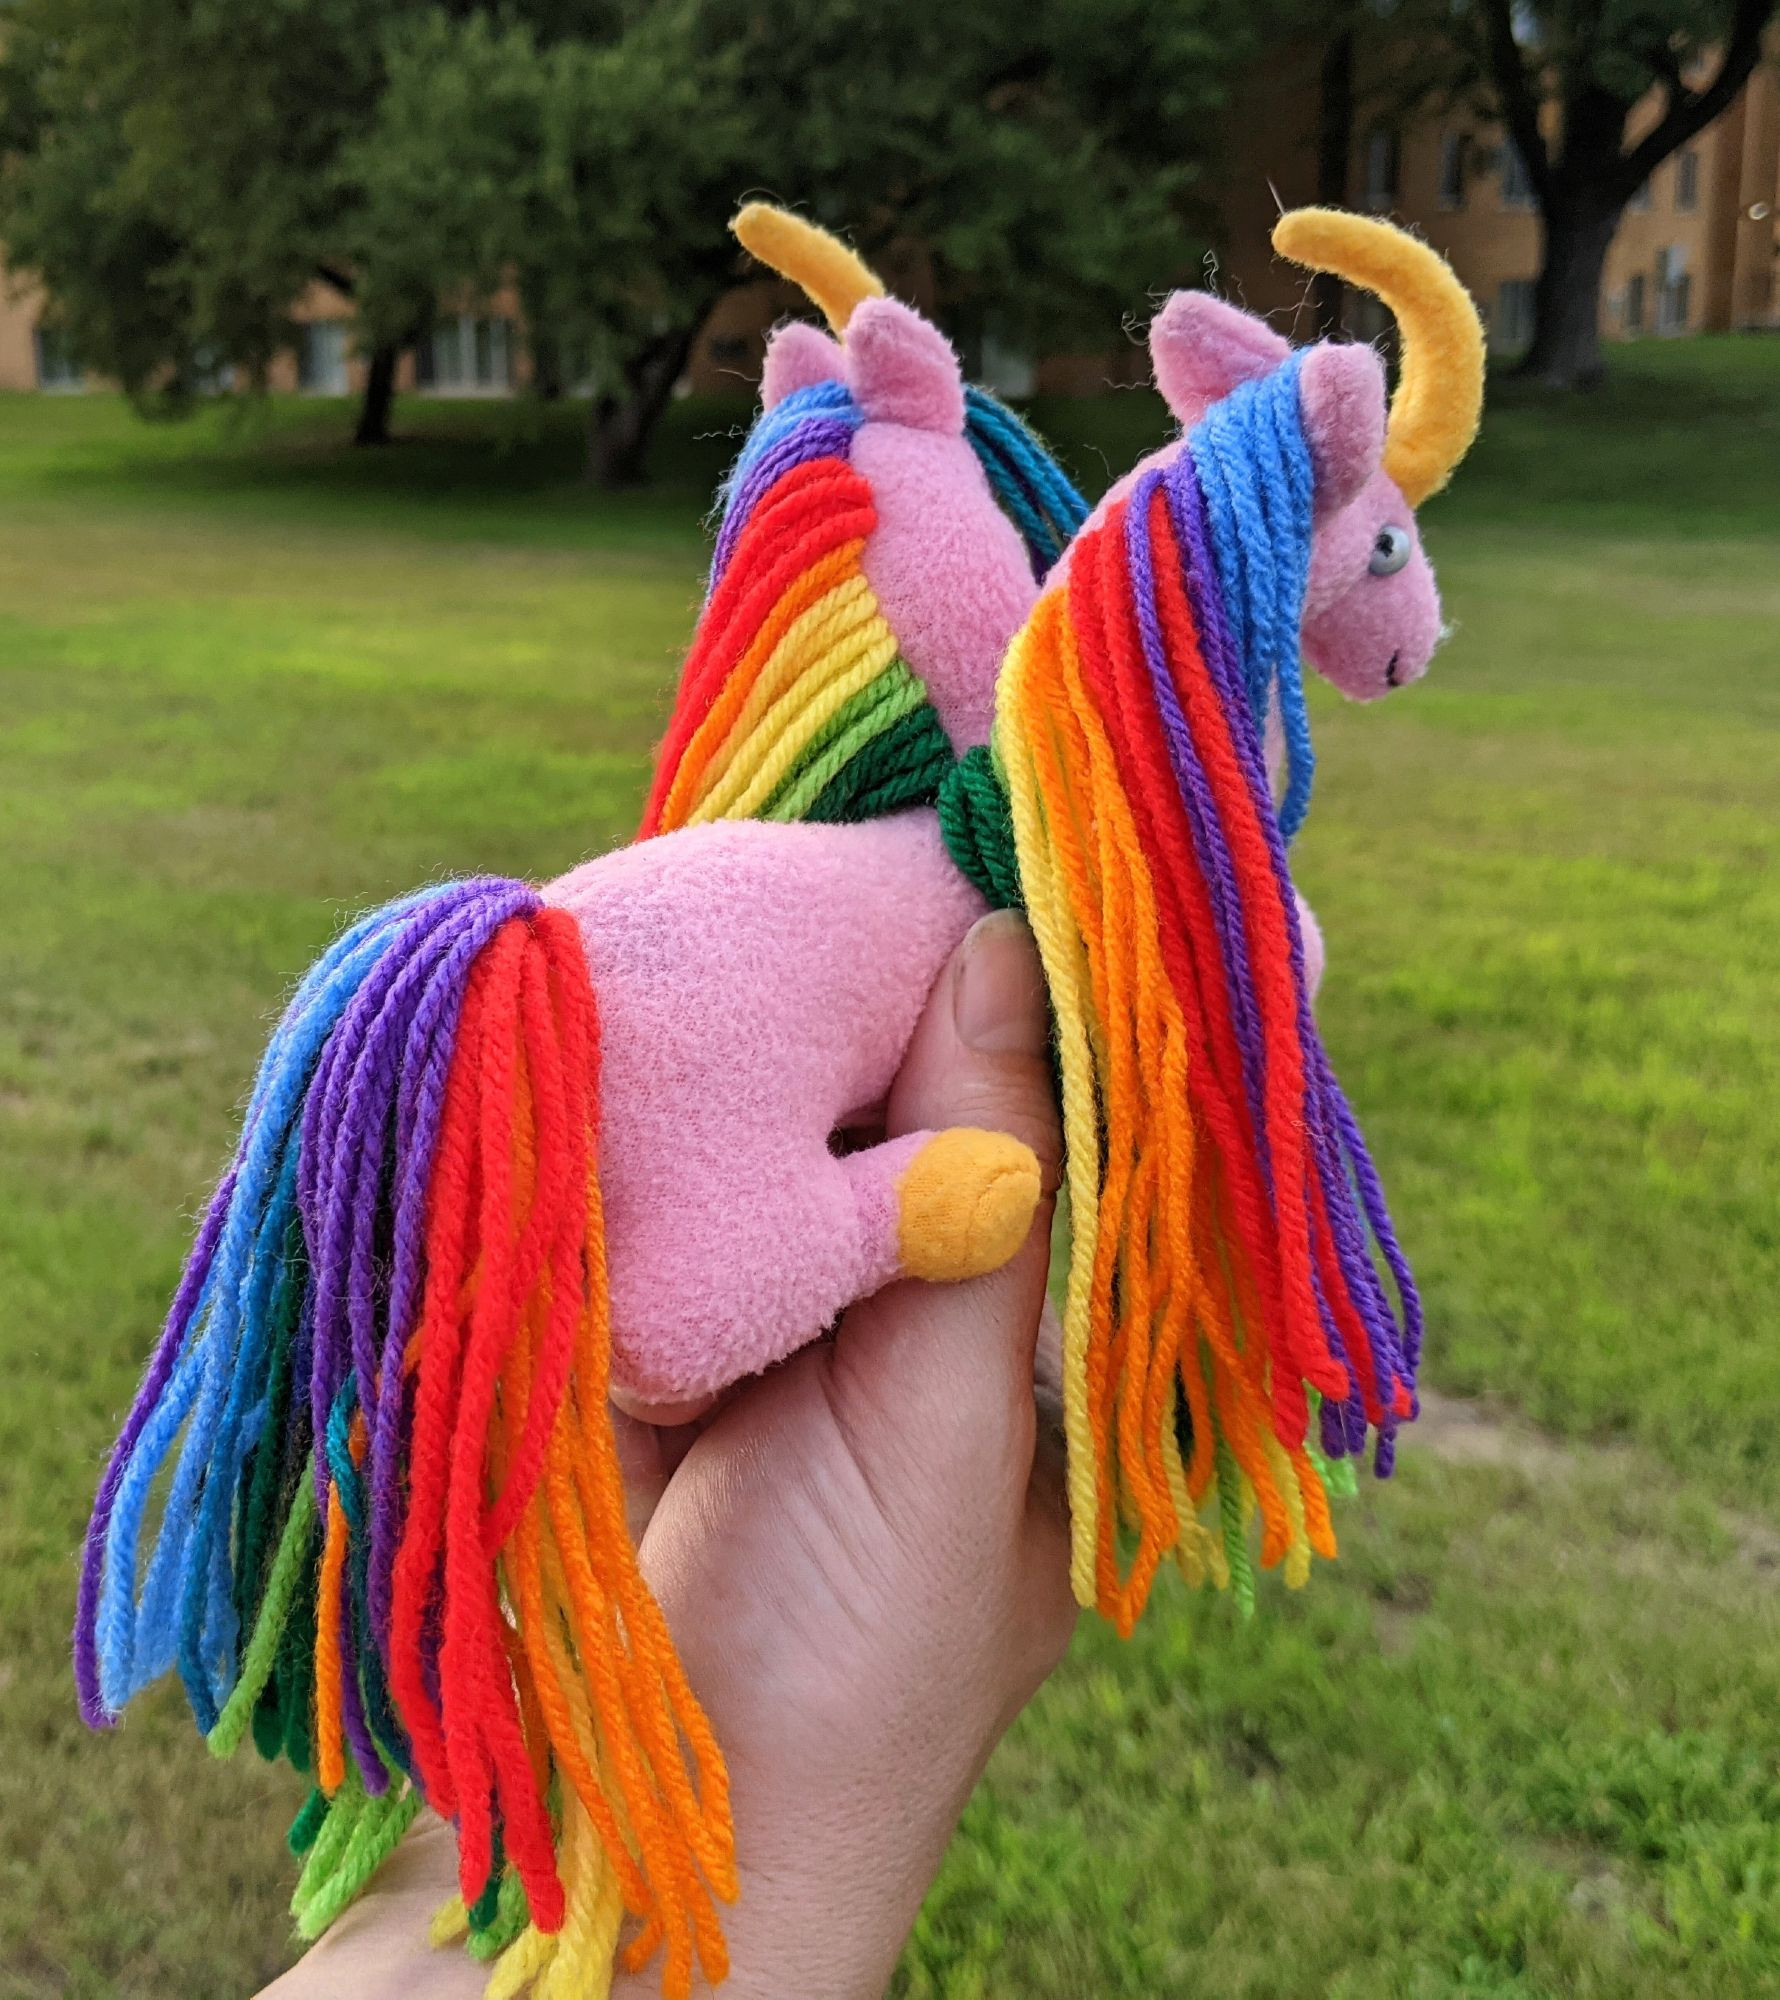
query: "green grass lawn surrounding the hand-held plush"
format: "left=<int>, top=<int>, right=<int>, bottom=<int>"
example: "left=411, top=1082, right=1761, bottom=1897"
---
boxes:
left=0, top=342, right=1780, bottom=2000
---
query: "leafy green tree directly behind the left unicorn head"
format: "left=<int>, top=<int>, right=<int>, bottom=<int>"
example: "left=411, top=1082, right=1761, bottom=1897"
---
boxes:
left=354, top=0, right=1250, bottom=484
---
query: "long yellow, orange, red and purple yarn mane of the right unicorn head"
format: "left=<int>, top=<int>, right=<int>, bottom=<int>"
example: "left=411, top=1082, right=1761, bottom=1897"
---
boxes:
left=994, top=450, right=1420, bottom=1630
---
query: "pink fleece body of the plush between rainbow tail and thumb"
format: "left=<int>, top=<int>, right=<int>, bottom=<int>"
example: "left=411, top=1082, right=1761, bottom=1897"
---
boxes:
left=546, top=812, right=984, bottom=1402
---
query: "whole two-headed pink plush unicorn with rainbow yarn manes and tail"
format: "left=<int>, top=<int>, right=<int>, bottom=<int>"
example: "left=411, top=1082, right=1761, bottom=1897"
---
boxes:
left=74, top=210, right=1482, bottom=1996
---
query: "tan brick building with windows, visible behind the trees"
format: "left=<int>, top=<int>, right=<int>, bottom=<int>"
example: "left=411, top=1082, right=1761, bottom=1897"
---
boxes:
left=0, top=48, right=1780, bottom=396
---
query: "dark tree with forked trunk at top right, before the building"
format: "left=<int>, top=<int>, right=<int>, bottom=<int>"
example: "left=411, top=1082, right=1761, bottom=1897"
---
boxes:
left=1456, top=0, right=1776, bottom=388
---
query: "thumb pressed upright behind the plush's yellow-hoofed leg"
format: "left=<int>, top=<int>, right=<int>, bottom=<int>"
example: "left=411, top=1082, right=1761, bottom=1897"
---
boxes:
left=842, top=910, right=1062, bottom=1412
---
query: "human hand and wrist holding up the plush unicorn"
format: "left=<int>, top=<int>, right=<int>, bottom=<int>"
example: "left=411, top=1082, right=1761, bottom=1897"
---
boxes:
left=616, top=914, right=1074, bottom=2000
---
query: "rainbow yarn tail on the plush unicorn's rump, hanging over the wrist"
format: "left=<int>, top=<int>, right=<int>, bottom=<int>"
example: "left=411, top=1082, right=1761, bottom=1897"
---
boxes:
left=74, top=880, right=736, bottom=1996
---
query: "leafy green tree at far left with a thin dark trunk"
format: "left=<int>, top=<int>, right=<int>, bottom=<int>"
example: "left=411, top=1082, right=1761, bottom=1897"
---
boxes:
left=0, top=0, right=442, bottom=442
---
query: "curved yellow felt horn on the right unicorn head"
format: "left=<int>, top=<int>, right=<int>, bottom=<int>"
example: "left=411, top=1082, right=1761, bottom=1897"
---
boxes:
left=1274, top=208, right=1484, bottom=506
